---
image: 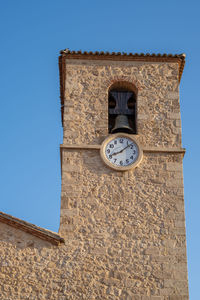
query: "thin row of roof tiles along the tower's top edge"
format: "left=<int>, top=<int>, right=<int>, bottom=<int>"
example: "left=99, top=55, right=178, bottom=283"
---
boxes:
left=60, top=48, right=186, bottom=60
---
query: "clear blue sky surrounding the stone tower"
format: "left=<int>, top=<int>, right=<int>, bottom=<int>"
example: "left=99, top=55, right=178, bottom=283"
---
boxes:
left=0, top=0, right=200, bottom=300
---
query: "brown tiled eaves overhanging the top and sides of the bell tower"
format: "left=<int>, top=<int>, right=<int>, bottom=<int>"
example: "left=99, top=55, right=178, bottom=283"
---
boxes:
left=59, top=49, right=185, bottom=122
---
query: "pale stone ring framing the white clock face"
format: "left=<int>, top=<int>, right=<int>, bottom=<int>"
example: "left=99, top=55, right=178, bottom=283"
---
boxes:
left=100, top=132, right=143, bottom=171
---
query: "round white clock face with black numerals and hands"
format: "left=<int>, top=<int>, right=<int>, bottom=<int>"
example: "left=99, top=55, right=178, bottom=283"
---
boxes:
left=104, top=135, right=139, bottom=167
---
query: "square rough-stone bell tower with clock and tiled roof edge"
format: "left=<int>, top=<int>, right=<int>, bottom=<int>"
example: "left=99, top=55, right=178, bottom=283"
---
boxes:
left=59, top=50, right=189, bottom=300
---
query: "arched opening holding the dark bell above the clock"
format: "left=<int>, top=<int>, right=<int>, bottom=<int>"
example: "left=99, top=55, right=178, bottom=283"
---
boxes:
left=108, top=83, right=137, bottom=134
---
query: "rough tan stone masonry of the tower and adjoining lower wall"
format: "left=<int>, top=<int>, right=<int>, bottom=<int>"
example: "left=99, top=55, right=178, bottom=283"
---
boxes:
left=0, top=60, right=188, bottom=300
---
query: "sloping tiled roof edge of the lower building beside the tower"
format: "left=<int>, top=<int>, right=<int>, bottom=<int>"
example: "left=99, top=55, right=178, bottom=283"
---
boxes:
left=0, top=212, right=64, bottom=246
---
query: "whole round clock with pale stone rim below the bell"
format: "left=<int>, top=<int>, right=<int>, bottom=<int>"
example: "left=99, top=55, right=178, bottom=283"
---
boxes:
left=100, top=133, right=143, bottom=171
